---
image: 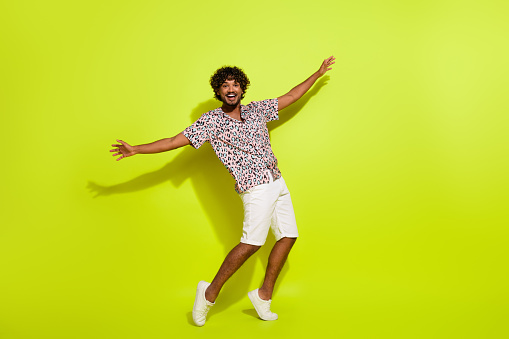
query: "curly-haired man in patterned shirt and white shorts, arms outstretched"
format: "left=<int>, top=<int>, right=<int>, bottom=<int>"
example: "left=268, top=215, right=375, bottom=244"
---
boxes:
left=110, top=56, right=335, bottom=326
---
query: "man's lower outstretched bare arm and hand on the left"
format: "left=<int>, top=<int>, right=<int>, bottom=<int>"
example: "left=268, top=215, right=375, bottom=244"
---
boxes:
left=110, top=133, right=190, bottom=161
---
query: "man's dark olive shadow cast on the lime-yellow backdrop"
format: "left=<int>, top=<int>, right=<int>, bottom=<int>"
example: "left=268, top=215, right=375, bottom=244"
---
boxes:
left=87, top=76, right=329, bottom=316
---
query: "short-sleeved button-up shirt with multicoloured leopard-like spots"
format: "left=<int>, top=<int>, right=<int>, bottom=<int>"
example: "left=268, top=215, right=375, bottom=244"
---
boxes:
left=182, top=99, right=281, bottom=193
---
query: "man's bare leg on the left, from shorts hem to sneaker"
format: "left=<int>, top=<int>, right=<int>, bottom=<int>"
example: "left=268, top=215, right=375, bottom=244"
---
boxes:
left=205, top=243, right=258, bottom=303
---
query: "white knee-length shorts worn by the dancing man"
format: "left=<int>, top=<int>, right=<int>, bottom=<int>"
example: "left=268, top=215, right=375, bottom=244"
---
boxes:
left=240, top=176, right=299, bottom=246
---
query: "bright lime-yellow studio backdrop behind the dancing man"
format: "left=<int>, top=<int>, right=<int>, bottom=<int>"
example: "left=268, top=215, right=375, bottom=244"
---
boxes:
left=0, top=0, right=509, bottom=339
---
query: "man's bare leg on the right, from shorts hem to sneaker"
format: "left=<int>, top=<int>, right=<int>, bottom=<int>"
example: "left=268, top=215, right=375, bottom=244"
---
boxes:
left=258, top=238, right=297, bottom=300
